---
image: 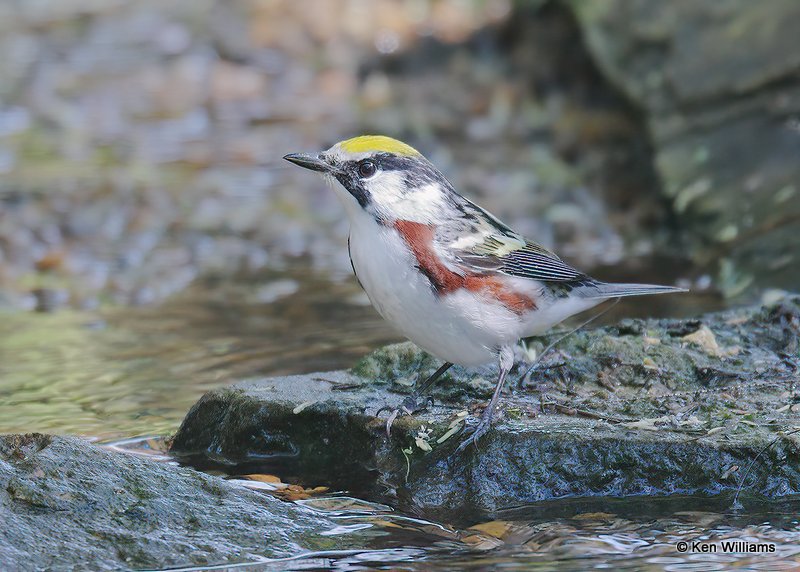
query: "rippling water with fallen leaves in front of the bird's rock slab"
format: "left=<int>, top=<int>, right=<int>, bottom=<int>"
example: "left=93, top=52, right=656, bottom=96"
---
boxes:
left=106, top=439, right=800, bottom=571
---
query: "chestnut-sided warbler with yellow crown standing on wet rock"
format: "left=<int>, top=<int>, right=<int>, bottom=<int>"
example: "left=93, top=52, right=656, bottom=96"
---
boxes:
left=284, top=135, right=682, bottom=448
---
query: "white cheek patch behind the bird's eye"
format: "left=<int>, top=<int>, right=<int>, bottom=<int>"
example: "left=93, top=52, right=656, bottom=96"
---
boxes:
left=364, top=178, right=445, bottom=224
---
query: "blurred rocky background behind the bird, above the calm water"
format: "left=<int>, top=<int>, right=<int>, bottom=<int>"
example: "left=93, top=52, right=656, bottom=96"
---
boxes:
left=0, top=0, right=800, bottom=310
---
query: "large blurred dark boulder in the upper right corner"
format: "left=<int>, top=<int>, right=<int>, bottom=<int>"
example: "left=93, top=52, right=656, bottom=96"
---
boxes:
left=568, top=0, right=800, bottom=296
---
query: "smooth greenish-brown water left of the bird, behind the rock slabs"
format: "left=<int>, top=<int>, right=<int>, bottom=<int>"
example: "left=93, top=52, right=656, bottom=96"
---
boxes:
left=0, top=267, right=397, bottom=438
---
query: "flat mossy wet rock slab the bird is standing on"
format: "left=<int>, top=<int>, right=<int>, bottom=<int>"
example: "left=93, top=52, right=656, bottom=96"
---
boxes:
left=172, top=298, right=800, bottom=518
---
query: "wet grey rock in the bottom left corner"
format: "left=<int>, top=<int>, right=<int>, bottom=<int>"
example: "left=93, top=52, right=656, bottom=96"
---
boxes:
left=0, top=434, right=360, bottom=570
